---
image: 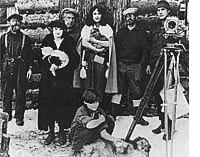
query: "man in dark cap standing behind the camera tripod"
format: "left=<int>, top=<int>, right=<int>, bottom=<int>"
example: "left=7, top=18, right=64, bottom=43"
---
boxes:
left=146, top=0, right=171, bottom=140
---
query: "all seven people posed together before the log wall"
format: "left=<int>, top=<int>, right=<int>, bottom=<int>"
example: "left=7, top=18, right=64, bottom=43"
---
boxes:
left=0, top=1, right=177, bottom=150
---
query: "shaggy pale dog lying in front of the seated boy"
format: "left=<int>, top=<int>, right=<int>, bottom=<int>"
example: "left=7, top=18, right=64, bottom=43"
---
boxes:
left=71, top=139, right=151, bottom=157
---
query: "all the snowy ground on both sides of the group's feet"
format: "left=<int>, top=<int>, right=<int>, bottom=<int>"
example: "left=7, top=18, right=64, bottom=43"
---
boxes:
left=3, top=110, right=189, bottom=157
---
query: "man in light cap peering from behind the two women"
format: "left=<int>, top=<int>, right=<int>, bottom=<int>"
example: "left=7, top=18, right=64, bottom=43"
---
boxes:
left=61, top=8, right=80, bottom=43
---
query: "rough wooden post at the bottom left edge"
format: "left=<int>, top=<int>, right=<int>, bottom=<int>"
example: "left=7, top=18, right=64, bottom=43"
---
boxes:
left=0, top=112, right=10, bottom=157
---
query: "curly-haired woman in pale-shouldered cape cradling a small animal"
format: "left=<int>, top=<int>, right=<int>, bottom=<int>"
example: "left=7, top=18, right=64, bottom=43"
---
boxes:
left=80, top=5, right=117, bottom=102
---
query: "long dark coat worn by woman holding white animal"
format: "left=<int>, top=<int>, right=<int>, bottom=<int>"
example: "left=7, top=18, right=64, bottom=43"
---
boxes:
left=38, top=34, right=79, bottom=130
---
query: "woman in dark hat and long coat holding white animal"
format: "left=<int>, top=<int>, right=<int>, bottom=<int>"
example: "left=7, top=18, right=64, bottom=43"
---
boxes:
left=38, top=20, right=79, bottom=145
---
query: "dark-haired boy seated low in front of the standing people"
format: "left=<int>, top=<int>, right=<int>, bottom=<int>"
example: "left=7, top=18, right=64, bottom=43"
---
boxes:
left=69, top=89, right=121, bottom=152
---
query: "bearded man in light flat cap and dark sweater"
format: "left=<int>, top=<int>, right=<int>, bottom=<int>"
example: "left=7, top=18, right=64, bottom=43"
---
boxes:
left=116, top=8, right=148, bottom=125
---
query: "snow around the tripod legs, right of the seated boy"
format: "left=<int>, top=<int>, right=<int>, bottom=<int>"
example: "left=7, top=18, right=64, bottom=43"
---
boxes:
left=113, top=116, right=189, bottom=157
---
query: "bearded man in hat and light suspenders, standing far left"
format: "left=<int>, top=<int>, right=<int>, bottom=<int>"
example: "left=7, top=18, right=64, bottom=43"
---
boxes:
left=0, top=14, right=33, bottom=126
